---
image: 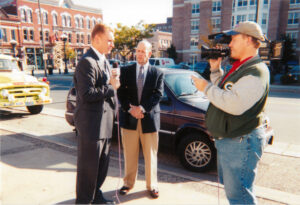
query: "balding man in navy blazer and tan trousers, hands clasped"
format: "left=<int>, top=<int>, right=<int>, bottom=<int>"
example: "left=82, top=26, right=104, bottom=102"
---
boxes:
left=118, top=40, right=163, bottom=198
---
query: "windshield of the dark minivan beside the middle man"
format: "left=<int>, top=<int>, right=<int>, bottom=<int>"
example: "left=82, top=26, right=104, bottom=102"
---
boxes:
left=165, top=72, right=202, bottom=97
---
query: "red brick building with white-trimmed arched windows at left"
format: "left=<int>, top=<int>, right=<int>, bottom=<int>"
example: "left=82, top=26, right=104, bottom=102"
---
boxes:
left=0, top=0, right=103, bottom=68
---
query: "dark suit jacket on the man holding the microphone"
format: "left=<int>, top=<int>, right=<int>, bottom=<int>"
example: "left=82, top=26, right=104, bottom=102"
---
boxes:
left=74, top=49, right=115, bottom=140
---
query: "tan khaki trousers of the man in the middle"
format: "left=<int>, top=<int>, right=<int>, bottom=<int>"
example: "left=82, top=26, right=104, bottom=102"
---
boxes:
left=121, top=120, right=158, bottom=190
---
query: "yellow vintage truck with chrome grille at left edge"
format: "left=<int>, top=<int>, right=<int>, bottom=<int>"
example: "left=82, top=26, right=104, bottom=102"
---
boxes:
left=0, top=54, right=52, bottom=114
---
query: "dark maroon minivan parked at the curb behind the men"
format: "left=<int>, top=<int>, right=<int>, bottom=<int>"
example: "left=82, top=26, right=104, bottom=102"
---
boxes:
left=66, top=68, right=274, bottom=172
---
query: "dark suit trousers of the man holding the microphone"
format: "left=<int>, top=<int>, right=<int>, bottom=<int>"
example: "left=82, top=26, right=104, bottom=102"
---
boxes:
left=76, top=136, right=111, bottom=204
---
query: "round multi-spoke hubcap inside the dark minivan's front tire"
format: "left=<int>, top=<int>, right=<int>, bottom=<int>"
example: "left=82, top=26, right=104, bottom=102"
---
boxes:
left=184, top=141, right=211, bottom=167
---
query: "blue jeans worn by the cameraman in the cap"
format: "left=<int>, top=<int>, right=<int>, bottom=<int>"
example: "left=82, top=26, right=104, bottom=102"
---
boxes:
left=215, top=127, right=266, bottom=204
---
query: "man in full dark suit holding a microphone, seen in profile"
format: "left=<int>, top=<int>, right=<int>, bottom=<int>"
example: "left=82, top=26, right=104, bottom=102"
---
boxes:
left=74, top=24, right=120, bottom=204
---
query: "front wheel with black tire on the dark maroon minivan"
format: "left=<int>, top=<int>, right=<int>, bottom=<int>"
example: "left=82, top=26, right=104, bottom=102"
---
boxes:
left=178, top=132, right=216, bottom=172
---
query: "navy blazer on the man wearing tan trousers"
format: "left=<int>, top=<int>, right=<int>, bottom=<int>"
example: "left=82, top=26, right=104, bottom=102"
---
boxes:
left=118, top=64, right=164, bottom=133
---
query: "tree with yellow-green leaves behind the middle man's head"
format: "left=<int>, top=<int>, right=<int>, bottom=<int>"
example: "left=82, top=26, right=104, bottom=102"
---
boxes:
left=113, top=21, right=155, bottom=60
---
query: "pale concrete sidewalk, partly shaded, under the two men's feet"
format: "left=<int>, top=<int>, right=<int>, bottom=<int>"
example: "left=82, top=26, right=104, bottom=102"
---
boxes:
left=0, top=130, right=228, bottom=205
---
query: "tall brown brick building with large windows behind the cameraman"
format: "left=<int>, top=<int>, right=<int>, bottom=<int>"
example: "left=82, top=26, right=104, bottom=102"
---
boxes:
left=172, top=0, right=300, bottom=62
